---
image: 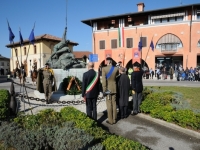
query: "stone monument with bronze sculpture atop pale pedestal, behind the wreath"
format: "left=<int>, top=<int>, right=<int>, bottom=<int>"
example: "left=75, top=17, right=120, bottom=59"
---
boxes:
left=34, top=27, right=87, bottom=101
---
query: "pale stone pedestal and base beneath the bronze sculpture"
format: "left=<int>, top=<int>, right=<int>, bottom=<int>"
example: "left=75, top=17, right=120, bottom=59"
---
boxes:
left=34, top=68, right=87, bottom=101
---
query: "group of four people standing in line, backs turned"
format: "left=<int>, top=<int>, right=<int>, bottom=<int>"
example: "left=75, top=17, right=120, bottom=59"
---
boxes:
left=82, top=57, right=143, bottom=125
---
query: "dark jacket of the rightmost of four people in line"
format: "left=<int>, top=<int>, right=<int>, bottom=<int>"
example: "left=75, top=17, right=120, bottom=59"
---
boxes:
left=131, top=70, right=143, bottom=92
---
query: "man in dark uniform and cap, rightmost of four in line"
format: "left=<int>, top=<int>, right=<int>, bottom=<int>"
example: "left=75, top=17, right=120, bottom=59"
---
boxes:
left=131, top=63, right=143, bottom=115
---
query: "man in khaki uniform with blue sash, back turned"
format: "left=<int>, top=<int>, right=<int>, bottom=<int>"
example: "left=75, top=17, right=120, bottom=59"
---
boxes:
left=102, top=57, right=119, bottom=125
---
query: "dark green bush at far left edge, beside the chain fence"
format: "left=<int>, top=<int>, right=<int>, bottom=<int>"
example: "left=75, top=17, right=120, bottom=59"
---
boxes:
left=0, top=89, right=10, bottom=119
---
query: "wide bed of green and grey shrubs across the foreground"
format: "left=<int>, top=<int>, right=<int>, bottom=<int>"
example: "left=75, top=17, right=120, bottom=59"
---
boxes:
left=0, top=107, right=147, bottom=150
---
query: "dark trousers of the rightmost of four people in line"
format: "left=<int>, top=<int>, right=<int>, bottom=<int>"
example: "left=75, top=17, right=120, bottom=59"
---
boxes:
left=133, top=92, right=142, bottom=113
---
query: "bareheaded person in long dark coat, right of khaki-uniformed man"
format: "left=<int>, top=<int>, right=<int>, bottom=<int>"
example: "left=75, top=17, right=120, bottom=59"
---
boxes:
left=118, top=67, right=130, bottom=119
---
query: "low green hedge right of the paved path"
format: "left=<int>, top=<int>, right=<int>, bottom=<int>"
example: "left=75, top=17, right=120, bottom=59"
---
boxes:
left=140, top=88, right=200, bottom=130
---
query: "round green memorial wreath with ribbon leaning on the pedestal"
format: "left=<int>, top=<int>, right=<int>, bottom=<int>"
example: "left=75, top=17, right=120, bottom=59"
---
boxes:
left=62, top=76, right=82, bottom=95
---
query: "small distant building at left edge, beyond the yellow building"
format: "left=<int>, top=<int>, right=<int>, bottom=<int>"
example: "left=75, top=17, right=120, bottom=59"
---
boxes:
left=0, top=55, right=10, bottom=75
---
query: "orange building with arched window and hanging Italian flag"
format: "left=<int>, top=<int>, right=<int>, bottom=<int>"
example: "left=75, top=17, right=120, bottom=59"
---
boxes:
left=82, top=3, right=200, bottom=69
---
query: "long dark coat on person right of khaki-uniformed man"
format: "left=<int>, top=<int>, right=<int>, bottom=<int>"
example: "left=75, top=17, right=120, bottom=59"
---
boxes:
left=118, top=74, right=130, bottom=106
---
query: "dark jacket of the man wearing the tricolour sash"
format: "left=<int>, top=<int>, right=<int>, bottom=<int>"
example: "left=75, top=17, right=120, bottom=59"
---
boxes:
left=82, top=69, right=100, bottom=98
